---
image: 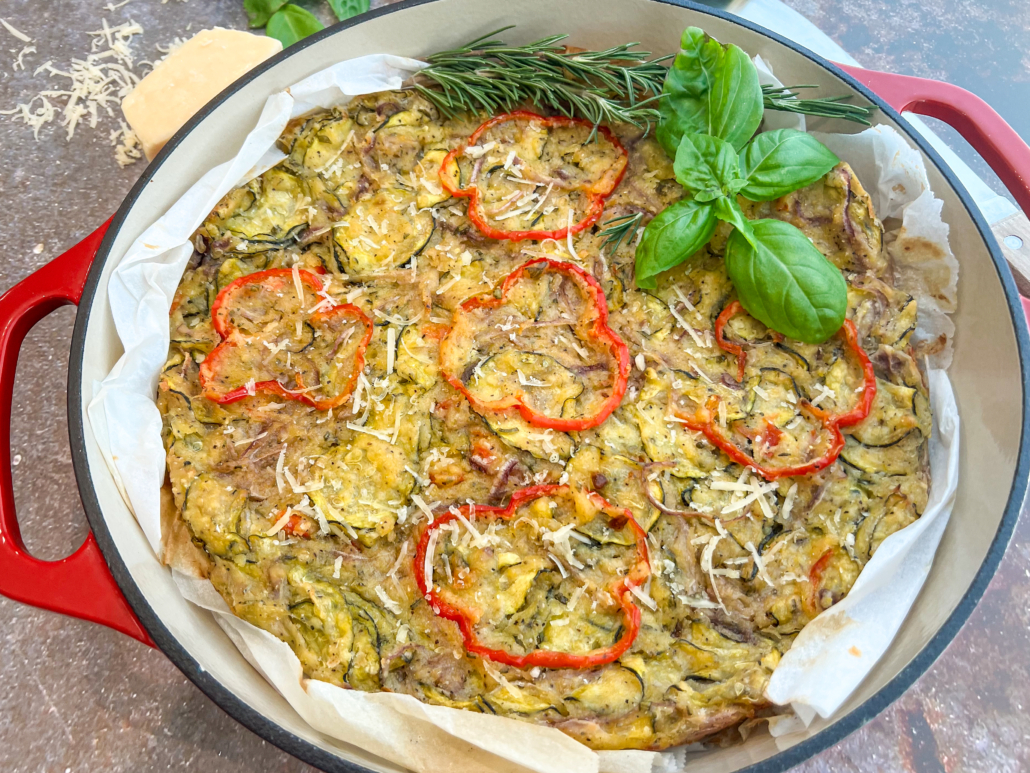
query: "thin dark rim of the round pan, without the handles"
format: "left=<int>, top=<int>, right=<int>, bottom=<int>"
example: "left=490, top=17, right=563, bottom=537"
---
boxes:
left=52, top=0, right=1030, bottom=773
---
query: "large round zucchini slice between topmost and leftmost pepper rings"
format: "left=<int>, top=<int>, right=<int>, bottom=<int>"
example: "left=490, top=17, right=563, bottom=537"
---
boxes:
left=333, top=188, right=436, bottom=274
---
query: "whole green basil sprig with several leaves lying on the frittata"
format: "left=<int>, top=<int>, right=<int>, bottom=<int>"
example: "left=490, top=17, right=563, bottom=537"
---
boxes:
left=637, top=27, right=848, bottom=343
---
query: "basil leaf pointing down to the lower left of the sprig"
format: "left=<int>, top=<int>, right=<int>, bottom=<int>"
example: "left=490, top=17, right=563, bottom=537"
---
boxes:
left=637, top=199, right=716, bottom=290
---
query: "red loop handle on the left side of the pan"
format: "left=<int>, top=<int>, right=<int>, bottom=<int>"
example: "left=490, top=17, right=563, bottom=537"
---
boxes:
left=0, top=221, right=153, bottom=646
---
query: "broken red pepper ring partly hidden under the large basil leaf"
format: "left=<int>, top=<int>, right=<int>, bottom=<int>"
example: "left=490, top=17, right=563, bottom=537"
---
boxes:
left=676, top=313, right=877, bottom=480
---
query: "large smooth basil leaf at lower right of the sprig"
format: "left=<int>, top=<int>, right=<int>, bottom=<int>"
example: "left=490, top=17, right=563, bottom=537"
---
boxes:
left=726, top=220, right=848, bottom=343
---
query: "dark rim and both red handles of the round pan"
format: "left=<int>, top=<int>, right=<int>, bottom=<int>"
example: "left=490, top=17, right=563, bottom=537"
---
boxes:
left=0, top=0, right=1030, bottom=771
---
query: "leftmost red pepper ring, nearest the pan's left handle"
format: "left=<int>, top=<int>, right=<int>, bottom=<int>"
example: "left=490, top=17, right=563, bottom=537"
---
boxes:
left=200, top=268, right=374, bottom=410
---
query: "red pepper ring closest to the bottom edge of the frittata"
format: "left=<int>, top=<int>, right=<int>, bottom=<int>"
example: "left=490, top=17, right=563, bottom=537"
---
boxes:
left=414, top=485, right=651, bottom=669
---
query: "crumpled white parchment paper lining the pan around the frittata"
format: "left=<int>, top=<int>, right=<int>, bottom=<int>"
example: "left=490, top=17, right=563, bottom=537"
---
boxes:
left=89, top=55, right=958, bottom=773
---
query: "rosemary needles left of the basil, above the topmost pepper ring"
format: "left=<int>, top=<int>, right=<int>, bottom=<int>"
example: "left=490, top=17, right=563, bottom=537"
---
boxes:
left=414, top=27, right=670, bottom=130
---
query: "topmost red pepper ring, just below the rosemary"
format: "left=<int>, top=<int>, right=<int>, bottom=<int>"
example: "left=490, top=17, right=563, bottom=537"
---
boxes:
left=440, top=110, right=629, bottom=241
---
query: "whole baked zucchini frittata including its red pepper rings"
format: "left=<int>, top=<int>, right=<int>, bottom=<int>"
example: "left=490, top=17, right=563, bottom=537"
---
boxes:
left=158, top=92, right=930, bottom=749
